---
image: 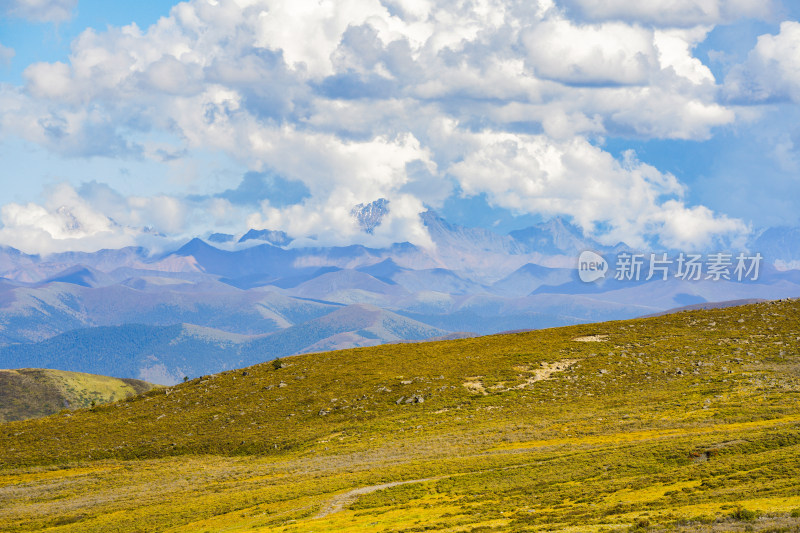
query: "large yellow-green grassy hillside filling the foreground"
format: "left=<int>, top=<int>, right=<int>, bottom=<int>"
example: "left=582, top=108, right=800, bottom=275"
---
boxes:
left=0, top=301, right=800, bottom=532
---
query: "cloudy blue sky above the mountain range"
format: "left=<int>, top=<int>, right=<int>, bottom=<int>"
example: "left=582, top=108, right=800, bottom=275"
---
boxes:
left=0, top=0, right=800, bottom=254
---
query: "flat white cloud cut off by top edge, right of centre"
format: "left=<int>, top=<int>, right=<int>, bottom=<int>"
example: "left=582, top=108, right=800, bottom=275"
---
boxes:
left=560, top=0, right=776, bottom=27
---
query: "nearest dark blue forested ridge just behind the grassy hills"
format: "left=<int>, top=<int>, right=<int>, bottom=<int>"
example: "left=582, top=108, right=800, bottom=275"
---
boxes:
left=0, top=302, right=447, bottom=385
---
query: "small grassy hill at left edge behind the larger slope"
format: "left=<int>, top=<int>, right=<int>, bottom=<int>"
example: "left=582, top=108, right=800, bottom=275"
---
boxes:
left=0, top=368, right=153, bottom=422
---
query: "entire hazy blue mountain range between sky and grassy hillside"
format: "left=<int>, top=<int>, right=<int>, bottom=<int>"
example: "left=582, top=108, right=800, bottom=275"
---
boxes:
left=0, top=210, right=800, bottom=384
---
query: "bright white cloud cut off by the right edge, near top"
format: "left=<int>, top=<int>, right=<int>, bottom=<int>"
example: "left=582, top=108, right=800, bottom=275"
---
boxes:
left=725, top=21, right=800, bottom=103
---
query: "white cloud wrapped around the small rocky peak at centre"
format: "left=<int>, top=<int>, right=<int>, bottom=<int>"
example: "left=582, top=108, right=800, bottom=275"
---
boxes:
left=248, top=131, right=436, bottom=246
